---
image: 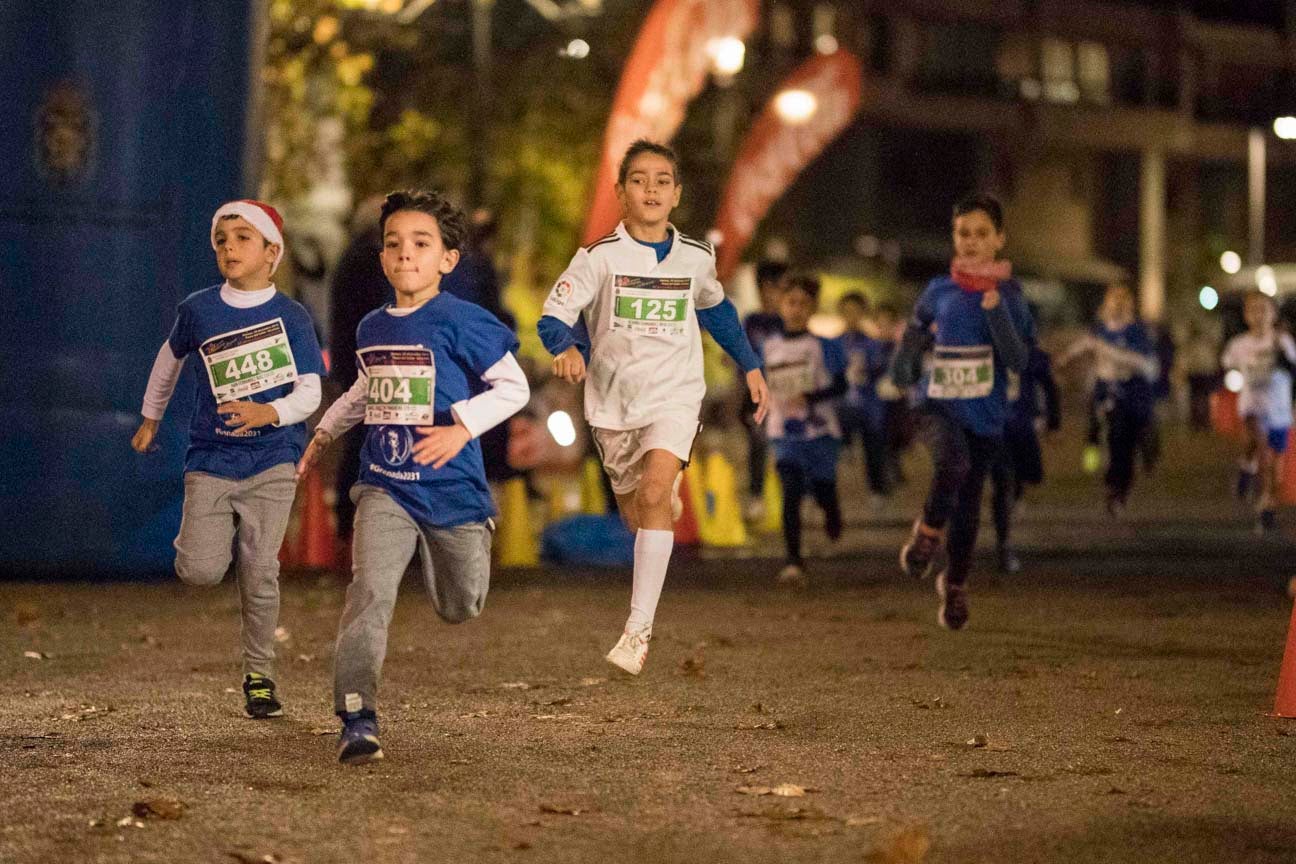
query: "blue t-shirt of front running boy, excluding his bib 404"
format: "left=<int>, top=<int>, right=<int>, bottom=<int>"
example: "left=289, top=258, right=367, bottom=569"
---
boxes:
left=355, top=294, right=517, bottom=529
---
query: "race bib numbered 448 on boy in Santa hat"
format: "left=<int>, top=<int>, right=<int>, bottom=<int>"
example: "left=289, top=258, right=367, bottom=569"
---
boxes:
left=198, top=319, right=297, bottom=404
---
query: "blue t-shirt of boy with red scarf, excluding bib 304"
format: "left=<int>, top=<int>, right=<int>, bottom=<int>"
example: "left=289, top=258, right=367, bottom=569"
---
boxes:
left=910, top=276, right=1036, bottom=437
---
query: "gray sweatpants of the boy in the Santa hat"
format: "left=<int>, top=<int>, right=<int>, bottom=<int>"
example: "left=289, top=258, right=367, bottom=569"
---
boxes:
left=175, top=462, right=297, bottom=677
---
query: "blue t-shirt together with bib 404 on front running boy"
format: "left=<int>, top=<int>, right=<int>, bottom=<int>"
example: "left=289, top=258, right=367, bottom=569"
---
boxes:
left=355, top=294, right=517, bottom=529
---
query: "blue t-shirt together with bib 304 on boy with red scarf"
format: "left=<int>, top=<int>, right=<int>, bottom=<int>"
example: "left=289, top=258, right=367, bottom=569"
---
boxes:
left=910, top=276, right=1036, bottom=437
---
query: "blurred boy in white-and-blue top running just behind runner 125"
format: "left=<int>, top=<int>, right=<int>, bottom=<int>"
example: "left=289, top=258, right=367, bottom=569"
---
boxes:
left=762, top=276, right=846, bottom=587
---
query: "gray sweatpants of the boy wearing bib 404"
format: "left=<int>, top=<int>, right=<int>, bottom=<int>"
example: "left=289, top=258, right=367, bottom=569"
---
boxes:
left=333, top=484, right=495, bottom=714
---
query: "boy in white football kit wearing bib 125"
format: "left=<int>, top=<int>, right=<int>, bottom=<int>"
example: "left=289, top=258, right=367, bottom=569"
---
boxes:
left=538, top=140, right=769, bottom=675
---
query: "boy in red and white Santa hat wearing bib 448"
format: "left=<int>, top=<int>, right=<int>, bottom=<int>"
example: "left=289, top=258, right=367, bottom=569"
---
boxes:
left=131, top=201, right=324, bottom=719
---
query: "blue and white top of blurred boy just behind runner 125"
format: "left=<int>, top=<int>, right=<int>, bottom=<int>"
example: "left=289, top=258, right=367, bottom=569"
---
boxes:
left=763, top=332, right=846, bottom=440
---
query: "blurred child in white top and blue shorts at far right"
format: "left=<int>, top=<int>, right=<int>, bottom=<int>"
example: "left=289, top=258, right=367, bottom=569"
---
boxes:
left=1220, top=291, right=1296, bottom=532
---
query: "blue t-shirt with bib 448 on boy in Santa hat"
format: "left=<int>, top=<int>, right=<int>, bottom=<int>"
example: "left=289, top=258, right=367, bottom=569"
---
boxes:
left=167, top=285, right=324, bottom=479
